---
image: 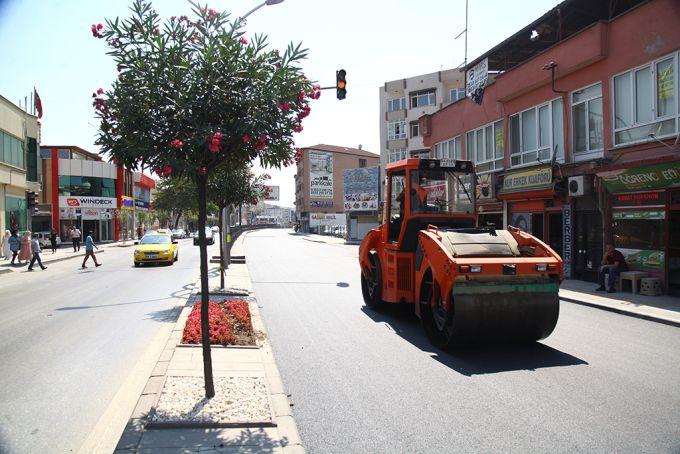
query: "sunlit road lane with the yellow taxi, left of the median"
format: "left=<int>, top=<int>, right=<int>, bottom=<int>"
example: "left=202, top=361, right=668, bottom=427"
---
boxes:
left=0, top=240, right=207, bottom=453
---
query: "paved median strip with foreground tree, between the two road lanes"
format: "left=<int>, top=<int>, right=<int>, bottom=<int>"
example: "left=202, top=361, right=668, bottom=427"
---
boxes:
left=115, top=232, right=305, bottom=454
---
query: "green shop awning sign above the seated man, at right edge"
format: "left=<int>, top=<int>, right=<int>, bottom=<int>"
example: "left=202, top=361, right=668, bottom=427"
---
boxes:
left=597, top=161, right=680, bottom=193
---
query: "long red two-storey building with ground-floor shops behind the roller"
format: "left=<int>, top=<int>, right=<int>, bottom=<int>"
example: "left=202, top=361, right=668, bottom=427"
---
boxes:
left=420, top=0, right=680, bottom=293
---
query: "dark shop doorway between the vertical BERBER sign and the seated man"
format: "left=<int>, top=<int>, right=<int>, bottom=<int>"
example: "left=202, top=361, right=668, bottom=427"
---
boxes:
left=573, top=211, right=602, bottom=282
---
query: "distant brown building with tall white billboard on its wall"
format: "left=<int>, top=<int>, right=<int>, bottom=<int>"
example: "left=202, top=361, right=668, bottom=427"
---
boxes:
left=295, top=144, right=380, bottom=232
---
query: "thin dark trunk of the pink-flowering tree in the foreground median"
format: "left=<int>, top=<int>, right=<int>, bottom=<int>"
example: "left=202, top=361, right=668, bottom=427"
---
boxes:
left=196, top=176, right=215, bottom=399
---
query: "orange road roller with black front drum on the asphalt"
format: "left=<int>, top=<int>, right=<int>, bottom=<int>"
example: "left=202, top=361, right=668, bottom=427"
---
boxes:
left=359, top=159, right=562, bottom=348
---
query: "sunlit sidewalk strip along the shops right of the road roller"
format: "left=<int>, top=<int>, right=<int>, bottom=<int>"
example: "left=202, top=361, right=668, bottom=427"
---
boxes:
left=560, top=279, right=680, bottom=327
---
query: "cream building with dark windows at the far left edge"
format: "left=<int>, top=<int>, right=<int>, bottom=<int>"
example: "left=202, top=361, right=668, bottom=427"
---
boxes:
left=0, top=96, right=41, bottom=234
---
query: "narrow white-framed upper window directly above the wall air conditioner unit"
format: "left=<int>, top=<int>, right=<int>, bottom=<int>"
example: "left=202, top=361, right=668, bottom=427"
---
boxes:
left=571, top=83, right=604, bottom=153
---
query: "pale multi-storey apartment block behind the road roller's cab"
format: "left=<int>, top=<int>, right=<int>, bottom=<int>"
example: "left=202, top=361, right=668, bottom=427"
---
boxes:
left=379, top=69, right=465, bottom=170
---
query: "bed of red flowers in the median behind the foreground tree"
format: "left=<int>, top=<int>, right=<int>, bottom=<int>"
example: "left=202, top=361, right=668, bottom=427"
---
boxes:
left=182, top=300, right=254, bottom=345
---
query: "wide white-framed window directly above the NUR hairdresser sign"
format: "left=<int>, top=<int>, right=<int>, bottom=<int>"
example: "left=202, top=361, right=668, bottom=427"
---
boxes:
left=509, top=98, right=564, bottom=166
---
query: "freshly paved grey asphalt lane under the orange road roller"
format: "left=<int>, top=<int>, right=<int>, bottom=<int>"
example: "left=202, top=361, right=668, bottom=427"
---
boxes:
left=245, top=230, right=680, bottom=453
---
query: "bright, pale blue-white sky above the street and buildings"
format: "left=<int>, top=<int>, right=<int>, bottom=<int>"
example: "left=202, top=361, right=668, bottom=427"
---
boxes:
left=0, top=0, right=558, bottom=206
